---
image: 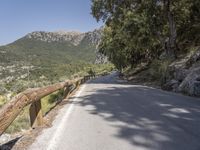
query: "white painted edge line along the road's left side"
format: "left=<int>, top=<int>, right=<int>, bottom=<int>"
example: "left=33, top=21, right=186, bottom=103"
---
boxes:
left=47, top=84, right=86, bottom=150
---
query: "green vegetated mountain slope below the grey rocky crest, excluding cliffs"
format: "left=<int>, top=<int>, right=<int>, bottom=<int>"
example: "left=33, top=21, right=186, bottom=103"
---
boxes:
left=0, top=38, right=96, bottom=88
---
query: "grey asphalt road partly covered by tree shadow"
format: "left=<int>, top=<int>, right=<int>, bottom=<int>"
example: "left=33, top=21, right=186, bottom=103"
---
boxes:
left=30, top=73, right=200, bottom=150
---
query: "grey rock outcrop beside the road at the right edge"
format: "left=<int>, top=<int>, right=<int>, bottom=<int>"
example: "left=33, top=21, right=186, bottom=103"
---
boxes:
left=162, top=49, right=200, bottom=96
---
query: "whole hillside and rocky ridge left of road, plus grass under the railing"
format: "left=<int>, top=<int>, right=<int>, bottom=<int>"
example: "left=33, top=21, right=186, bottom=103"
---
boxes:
left=0, top=29, right=114, bottom=133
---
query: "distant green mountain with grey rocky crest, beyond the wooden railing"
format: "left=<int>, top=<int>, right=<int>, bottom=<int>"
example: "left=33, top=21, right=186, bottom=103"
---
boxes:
left=0, top=28, right=105, bottom=92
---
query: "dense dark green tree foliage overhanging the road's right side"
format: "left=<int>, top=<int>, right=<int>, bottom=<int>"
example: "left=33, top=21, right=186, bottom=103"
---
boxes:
left=92, top=0, right=200, bottom=70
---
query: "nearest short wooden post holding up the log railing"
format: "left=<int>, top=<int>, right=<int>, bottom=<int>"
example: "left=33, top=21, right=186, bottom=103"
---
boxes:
left=29, top=100, right=43, bottom=128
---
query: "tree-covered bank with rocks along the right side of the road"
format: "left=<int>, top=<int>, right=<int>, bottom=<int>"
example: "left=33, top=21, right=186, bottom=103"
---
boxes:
left=92, top=0, right=200, bottom=96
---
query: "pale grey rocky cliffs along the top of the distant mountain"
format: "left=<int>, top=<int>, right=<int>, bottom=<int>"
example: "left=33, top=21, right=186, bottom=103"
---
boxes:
left=25, top=28, right=108, bottom=64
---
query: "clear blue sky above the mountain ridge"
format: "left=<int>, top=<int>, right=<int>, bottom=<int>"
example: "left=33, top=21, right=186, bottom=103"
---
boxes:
left=0, top=0, right=103, bottom=45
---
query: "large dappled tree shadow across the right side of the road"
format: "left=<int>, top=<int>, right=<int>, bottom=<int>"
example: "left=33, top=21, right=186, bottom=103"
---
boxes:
left=74, top=80, right=200, bottom=150
